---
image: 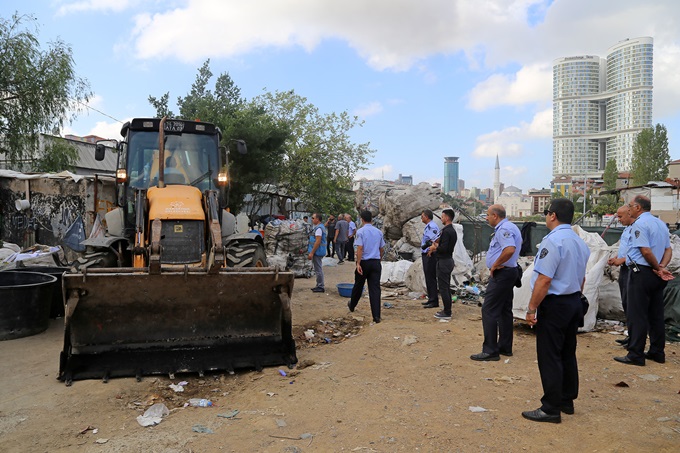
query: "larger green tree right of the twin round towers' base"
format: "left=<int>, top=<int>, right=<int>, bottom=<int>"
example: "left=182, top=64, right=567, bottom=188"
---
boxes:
left=631, top=124, right=671, bottom=186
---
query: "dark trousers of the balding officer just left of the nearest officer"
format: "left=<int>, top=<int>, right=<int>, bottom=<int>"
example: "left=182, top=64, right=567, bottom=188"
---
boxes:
left=482, top=266, right=518, bottom=355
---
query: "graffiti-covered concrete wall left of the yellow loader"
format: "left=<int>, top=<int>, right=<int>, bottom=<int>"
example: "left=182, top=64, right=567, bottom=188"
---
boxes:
left=0, top=176, right=115, bottom=260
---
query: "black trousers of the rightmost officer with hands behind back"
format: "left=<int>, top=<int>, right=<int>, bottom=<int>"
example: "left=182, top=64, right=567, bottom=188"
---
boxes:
left=626, top=266, right=666, bottom=361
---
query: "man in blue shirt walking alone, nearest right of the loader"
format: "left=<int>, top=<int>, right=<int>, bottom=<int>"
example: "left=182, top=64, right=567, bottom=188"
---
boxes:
left=347, top=211, right=385, bottom=323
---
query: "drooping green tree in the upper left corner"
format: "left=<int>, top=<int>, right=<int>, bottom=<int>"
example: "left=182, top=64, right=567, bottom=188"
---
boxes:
left=0, top=13, right=92, bottom=166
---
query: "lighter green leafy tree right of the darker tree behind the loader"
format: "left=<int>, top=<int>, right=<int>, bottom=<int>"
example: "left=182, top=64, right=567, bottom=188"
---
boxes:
left=254, top=90, right=374, bottom=214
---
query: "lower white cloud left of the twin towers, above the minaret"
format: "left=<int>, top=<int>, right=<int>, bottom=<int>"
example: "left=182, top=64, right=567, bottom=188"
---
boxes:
left=472, top=109, right=552, bottom=158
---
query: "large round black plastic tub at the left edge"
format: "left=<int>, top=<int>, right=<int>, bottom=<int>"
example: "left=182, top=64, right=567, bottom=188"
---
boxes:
left=0, top=271, right=57, bottom=340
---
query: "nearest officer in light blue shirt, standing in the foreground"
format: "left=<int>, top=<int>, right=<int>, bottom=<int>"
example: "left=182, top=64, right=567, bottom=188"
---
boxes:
left=522, top=198, right=590, bottom=423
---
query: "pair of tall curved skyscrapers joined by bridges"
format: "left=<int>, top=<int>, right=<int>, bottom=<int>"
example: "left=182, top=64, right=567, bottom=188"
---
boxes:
left=553, top=37, right=654, bottom=177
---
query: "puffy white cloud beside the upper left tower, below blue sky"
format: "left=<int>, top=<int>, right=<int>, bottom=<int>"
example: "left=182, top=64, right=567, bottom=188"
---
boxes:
left=467, top=63, right=552, bottom=111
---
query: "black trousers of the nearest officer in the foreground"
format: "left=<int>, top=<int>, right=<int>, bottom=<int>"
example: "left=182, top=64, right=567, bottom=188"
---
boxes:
left=536, top=293, right=583, bottom=415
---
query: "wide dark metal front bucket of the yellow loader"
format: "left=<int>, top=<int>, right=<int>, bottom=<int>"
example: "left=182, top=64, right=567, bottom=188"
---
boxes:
left=59, top=268, right=297, bottom=385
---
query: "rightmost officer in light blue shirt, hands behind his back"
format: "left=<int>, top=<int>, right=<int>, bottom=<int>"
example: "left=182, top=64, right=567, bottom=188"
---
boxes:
left=614, top=195, right=673, bottom=366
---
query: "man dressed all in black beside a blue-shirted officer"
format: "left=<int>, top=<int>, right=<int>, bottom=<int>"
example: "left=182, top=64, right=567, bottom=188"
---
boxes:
left=429, top=208, right=458, bottom=319
